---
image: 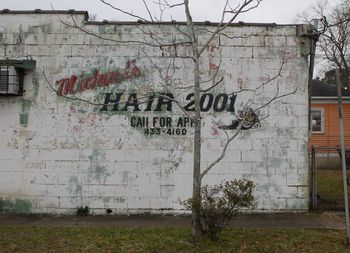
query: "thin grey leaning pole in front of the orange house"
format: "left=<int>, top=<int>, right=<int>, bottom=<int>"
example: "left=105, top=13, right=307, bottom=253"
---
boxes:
left=335, top=69, right=350, bottom=245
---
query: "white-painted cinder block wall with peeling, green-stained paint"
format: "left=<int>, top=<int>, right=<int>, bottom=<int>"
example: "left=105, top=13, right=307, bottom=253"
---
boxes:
left=0, top=13, right=309, bottom=214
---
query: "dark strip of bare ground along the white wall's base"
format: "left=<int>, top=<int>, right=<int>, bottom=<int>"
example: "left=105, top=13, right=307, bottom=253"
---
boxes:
left=0, top=212, right=345, bottom=230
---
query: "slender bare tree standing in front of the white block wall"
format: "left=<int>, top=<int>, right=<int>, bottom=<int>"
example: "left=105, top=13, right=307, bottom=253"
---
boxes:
left=44, top=0, right=296, bottom=238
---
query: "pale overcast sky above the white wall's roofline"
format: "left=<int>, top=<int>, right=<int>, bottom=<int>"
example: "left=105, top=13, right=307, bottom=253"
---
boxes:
left=0, top=0, right=316, bottom=24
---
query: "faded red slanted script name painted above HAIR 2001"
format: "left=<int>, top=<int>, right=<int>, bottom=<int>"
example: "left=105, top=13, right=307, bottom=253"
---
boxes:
left=56, top=60, right=142, bottom=96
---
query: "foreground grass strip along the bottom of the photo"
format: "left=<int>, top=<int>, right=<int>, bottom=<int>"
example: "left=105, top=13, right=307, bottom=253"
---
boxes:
left=0, top=226, right=350, bottom=253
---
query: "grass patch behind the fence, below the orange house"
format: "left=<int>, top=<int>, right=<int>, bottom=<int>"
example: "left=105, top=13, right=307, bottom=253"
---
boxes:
left=317, top=170, right=350, bottom=211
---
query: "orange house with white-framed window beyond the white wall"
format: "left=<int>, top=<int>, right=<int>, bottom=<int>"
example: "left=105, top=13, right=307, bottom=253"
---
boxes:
left=309, top=83, right=350, bottom=167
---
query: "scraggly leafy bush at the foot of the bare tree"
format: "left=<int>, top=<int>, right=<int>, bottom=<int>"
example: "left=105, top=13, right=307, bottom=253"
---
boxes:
left=184, top=179, right=255, bottom=239
